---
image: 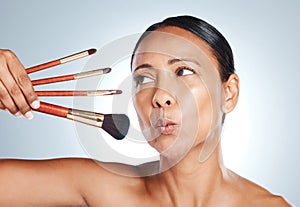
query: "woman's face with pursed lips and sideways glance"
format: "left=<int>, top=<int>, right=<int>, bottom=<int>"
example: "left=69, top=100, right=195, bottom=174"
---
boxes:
left=132, top=27, right=223, bottom=158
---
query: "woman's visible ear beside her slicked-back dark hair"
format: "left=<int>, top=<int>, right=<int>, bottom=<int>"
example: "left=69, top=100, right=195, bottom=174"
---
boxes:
left=222, top=74, right=240, bottom=114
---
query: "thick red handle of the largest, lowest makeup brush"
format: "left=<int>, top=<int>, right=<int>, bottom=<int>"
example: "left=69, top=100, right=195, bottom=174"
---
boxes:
left=34, top=102, right=69, bottom=118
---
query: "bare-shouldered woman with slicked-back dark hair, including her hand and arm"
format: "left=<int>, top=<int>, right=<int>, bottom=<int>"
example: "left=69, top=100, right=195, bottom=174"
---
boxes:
left=0, top=16, right=290, bottom=207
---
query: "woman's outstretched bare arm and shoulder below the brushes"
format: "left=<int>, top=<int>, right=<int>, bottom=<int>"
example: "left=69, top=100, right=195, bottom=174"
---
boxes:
left=0, top=158, right=146, bottom=206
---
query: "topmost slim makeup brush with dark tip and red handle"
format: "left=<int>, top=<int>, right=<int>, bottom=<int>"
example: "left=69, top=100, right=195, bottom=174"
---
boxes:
left=26, top=49, right=97, bottom=74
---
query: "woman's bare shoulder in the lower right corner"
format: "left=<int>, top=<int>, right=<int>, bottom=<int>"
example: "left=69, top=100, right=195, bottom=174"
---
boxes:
left=226, top=172, right=292, bottom=207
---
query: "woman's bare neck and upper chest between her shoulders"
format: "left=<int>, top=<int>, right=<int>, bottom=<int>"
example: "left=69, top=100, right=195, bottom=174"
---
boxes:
left=158, top=144, right=226, bottom=206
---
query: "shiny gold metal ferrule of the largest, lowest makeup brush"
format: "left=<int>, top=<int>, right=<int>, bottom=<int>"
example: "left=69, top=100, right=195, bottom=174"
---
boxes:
left=67, top=109, right=104, bottom=128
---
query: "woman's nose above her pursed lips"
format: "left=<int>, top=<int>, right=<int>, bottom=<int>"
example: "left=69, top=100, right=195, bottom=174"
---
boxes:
left=152, top=88, right=175, bottom=108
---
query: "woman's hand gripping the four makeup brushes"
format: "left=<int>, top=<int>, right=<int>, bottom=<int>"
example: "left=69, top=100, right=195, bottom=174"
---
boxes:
left=0, top=50, right=40, bottom=119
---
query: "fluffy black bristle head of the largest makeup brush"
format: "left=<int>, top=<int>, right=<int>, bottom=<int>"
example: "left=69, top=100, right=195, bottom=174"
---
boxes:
left=102, top=114, right=130, bottom=140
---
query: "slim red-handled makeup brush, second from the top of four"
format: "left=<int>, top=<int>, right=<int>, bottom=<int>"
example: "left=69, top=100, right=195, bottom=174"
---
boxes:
left=31, top=68, right=111, bottom=86
